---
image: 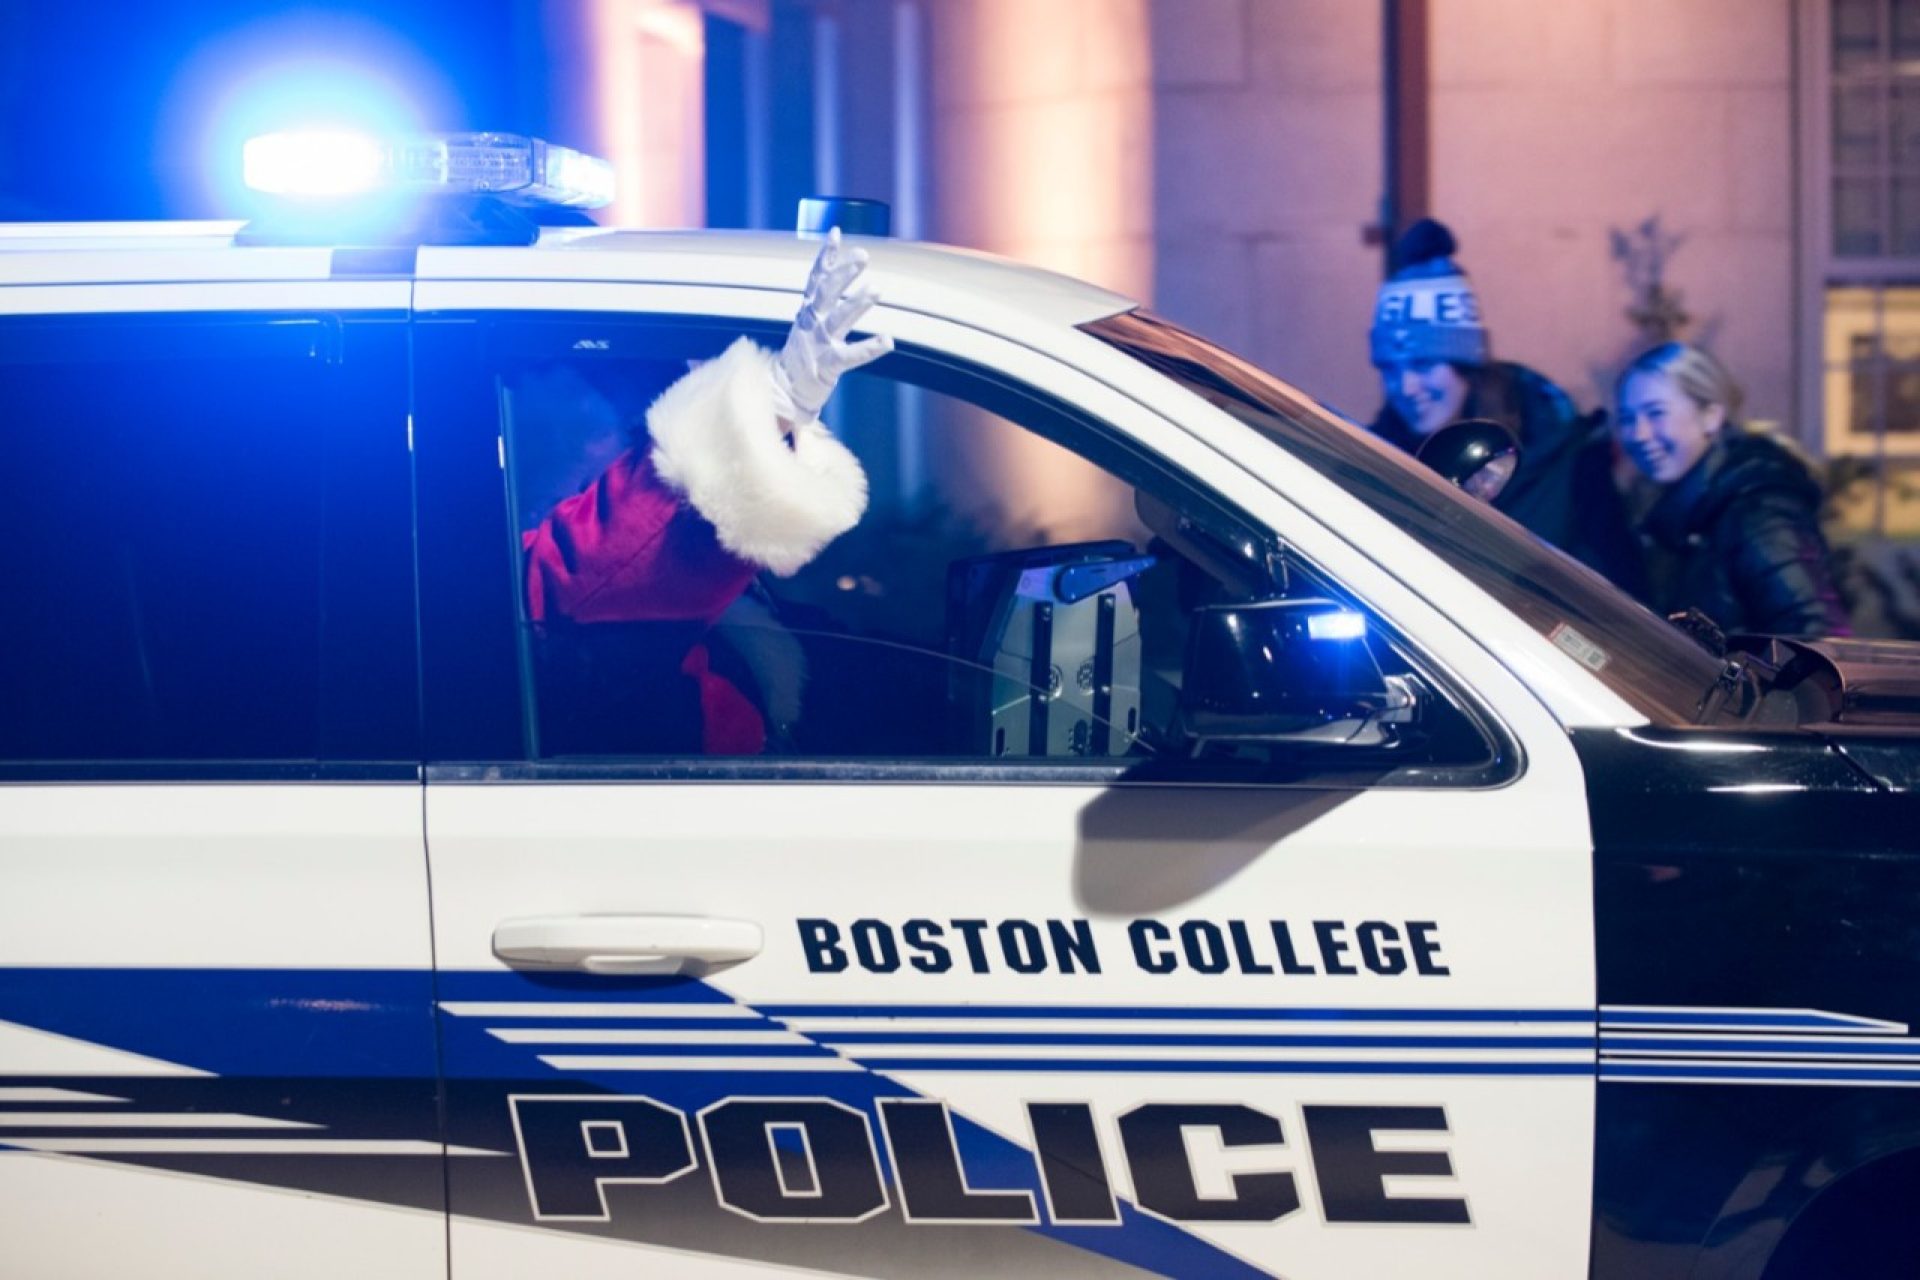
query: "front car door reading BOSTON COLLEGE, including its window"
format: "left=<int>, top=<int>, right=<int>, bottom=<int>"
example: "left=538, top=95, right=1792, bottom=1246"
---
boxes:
left=419, top=282, right=1594, bottom=1280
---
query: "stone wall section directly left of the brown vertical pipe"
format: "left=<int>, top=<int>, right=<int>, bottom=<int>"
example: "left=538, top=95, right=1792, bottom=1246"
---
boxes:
left=1152, top=0, right=1390, bottom=416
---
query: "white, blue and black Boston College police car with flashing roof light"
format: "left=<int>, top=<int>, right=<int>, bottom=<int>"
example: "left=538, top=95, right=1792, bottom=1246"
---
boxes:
left=0, top=136, right=1920, bottom=1280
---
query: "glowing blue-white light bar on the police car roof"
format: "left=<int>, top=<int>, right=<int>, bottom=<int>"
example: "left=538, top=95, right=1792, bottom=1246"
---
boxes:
left=242, top=132, right=614, bottom=209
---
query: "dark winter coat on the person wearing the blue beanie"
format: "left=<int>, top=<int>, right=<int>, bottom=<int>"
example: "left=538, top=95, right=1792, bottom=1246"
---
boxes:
left=1369, top=363, right=1647, bottom=597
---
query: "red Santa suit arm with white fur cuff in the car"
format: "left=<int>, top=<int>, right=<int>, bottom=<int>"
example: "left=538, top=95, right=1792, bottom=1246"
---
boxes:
left=522, top=338, right=866, bottom=754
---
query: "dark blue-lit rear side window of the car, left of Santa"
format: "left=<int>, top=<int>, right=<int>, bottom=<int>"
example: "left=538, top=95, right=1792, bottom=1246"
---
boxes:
left=0, top=315, right=419, bottom=762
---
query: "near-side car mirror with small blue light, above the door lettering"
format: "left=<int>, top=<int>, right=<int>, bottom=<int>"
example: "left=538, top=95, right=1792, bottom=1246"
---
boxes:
left=1181, top=599, right=1417, bottom=745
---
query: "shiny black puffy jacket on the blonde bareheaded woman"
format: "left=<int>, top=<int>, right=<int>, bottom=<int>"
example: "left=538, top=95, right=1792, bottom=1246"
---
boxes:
left=1642, top=428, right=1849, bottom=635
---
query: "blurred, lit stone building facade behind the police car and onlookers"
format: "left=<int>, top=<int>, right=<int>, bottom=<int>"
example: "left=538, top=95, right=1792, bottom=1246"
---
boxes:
left=0, top=0, right=1920, bottom=618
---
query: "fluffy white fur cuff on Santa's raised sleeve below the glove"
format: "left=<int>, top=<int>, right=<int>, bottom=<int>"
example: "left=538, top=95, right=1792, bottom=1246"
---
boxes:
left=647, top=338, right=866, bottom=578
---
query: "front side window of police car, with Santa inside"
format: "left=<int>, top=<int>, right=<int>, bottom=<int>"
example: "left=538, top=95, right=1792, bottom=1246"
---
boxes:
left=472, top=320, right=1498, bottom=775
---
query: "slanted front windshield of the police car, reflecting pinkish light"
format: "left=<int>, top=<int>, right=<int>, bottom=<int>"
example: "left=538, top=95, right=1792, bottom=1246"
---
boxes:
left=1081, top=311, right=1722, bottom=725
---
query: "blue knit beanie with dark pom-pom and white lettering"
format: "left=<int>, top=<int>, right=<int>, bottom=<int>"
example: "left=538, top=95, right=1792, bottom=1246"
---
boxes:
left=1367, top=217, right=1490, bottom=367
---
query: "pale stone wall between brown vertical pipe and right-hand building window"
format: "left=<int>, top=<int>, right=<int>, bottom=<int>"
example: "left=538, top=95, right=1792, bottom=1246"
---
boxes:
left=1432, top=0, right=1795, bottom=420
